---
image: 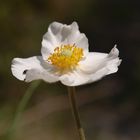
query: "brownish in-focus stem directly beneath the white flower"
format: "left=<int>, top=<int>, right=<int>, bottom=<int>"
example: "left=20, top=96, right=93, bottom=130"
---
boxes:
left=68, top=87, right=86, bottom=140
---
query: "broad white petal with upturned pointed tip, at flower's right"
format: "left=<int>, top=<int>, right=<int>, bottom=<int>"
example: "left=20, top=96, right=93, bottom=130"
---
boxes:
left=79, top=47, right=121, bottom=82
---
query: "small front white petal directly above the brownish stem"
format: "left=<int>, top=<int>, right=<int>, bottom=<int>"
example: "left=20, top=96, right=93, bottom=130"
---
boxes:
left=59, top=70, right=90, bottom=86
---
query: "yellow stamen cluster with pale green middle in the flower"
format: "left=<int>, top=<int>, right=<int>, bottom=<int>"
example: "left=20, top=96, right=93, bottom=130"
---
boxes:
left=48, top=44, right=83, bottom=71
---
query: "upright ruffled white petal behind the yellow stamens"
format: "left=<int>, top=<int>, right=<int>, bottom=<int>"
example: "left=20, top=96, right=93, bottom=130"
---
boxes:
left=41, top=22, right=88, bottom=60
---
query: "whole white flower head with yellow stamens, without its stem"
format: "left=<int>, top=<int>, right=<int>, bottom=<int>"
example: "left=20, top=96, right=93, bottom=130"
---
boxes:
left=11, top=22, right=121, bottom=86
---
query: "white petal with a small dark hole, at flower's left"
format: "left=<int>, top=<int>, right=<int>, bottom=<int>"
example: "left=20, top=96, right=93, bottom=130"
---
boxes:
left=11, top=56, right=58, bottom=83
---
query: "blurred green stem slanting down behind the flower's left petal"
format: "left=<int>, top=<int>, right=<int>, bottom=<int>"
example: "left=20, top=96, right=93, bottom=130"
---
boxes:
left=7, top=81, right=41, bottom=140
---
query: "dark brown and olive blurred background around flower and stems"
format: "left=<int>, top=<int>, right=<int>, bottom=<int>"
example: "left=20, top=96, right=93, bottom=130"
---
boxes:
left=0, top=0, right=140, bottom=140
